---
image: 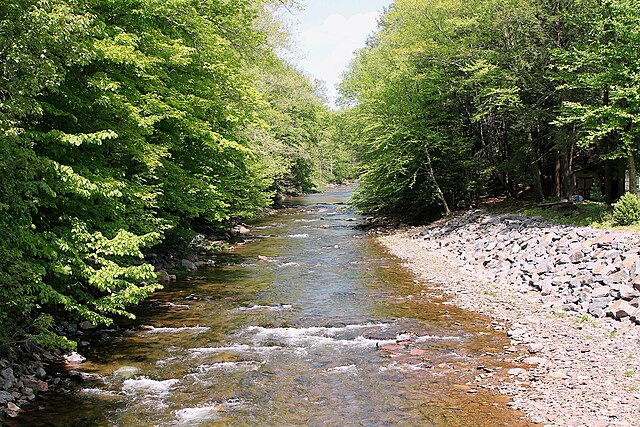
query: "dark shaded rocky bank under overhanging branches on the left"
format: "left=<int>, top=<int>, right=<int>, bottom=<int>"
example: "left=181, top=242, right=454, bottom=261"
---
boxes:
left=0, top=223, right=249, bottom=421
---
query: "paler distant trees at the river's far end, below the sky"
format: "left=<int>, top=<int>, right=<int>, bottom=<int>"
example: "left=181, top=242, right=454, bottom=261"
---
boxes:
left=241, top=58, right=350, bottom=194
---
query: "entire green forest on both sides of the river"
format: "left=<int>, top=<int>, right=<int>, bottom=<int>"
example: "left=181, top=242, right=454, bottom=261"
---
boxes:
left=0, top=0, right=640, bottom=353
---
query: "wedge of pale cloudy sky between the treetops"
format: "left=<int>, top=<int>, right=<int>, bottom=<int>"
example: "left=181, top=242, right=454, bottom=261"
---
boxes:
left=286, top=0, right=392, bottom=105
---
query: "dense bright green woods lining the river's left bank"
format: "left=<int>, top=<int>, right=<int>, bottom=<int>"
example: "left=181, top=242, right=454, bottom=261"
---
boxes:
left=0, top=0, right=351, bottom=353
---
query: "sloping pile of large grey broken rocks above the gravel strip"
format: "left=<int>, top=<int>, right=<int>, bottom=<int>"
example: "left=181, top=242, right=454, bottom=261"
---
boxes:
left=415, top=210, right=640, bottom=324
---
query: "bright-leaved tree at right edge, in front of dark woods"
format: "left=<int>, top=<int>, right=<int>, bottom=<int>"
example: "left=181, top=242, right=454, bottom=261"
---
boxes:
left=555, top=0, right=640, bottom=197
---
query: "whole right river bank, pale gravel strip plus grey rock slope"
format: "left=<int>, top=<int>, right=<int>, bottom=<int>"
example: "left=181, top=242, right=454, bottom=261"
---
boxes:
left=379, top=211, right=640, bottom=427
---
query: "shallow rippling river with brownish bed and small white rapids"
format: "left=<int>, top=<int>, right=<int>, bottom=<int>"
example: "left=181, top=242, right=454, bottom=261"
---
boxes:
left=15, top=187, right=530, bottom=427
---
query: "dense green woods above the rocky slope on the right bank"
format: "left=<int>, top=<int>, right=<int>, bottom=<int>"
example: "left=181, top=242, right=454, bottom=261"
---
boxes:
left=341, top=0, right=640, bottom=218
